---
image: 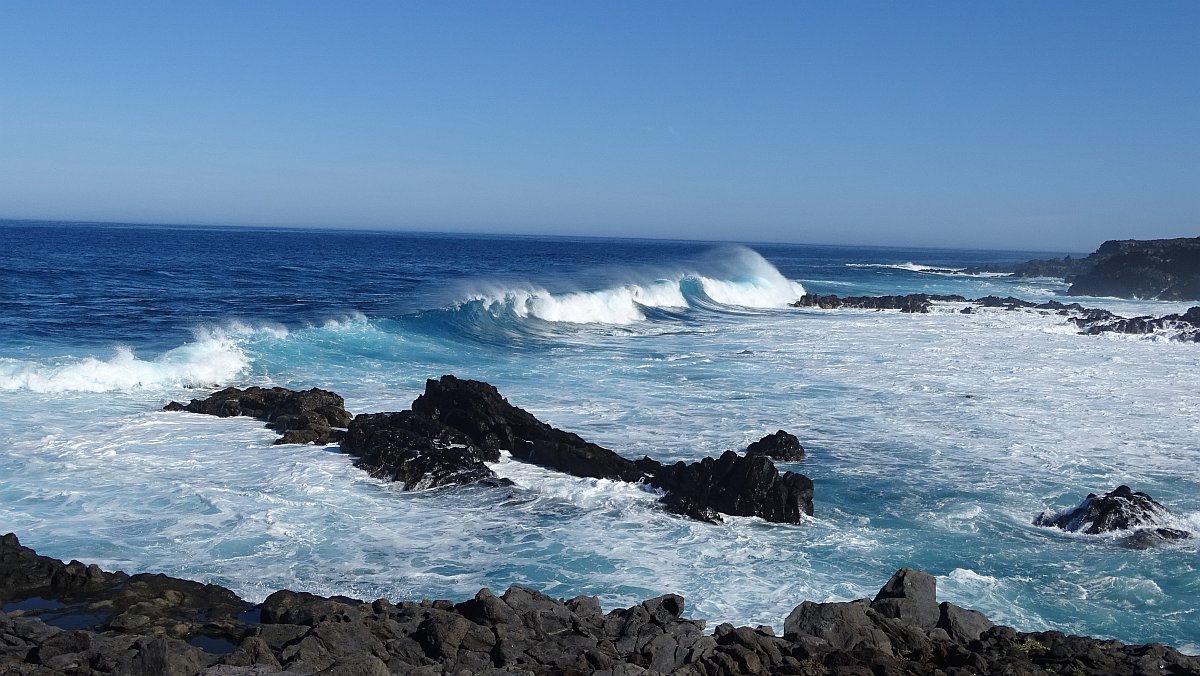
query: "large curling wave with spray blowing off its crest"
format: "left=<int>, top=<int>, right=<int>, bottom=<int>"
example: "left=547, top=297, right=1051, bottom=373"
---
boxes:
left=457, top=247, right=804, bottom=325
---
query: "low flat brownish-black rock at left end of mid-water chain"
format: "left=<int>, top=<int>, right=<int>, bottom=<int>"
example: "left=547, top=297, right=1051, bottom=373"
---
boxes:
left=163, top=387, right=353, bottom=444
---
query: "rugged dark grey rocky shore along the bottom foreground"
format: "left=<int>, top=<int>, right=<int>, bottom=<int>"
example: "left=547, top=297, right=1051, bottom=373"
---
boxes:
left=0, top=533, right=1200, bottom=676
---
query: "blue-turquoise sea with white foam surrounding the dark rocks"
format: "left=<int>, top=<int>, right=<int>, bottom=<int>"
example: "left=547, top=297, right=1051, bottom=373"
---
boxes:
left=0, top=221, right=1200, bottom=653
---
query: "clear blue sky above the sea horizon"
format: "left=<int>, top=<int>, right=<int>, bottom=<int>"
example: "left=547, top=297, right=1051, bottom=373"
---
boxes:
left=0, top=0, right=1200, bottom=251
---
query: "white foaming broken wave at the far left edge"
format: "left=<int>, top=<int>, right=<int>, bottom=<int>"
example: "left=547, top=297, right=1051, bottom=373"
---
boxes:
left=0, top=324, right=274, bottom=393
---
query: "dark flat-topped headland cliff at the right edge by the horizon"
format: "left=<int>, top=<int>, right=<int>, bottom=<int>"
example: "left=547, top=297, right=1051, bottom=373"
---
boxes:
left=1067, top=238, right=1200, bottom=300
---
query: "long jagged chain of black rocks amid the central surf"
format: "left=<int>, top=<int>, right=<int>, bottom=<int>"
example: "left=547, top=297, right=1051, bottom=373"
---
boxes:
left=166, top=376, right=812, bottom=524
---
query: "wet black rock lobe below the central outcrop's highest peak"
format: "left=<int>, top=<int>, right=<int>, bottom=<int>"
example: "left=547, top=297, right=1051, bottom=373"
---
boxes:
left=342, top=411, right=511, bottom=490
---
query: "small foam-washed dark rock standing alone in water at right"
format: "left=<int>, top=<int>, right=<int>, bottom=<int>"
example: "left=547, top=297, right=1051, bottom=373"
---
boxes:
left=1033, top=485, right=1190, bottom=549
